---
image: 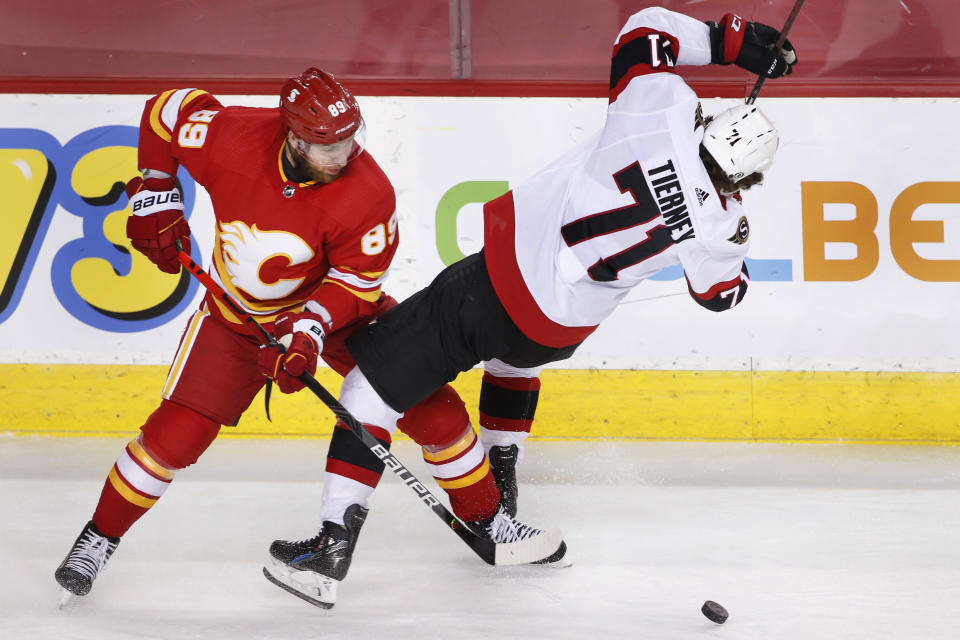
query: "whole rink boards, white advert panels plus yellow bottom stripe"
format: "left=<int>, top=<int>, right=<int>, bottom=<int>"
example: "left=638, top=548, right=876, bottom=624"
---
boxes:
left=0, top=95, right=960, bottom=442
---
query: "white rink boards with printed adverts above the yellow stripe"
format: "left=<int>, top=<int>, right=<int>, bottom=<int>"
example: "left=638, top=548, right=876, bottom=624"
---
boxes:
left=0, top=95, right=960, bottom=372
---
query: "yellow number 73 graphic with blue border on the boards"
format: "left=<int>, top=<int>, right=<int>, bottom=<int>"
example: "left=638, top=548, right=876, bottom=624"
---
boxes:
left=0, top=126, right=199, bottom=332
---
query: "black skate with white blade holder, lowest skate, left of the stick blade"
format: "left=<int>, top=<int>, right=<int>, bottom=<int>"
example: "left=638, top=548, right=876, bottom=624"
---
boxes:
left=263, top=504, right=369, bottom=609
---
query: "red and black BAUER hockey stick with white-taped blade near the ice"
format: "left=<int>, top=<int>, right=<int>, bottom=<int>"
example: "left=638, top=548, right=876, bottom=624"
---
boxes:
left=177, top=240, right=563, bottom=565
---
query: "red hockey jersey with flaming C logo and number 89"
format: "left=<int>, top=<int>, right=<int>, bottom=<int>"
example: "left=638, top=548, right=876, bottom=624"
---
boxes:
left=139, top=89, right=398, bottom=332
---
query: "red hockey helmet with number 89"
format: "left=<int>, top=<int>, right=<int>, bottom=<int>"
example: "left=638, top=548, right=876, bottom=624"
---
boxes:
left=280, top=67, right=363, bottom=144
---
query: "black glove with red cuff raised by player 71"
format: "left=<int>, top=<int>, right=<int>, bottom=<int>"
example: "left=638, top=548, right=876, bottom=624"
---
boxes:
left=707, top=13, right=797, bottom=78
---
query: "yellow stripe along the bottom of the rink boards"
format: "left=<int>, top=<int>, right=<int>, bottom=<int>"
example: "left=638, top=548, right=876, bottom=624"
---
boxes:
left=0, top=364, right=960, bottom=444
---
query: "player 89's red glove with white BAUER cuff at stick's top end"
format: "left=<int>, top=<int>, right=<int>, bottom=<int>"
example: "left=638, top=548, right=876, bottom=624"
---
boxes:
left=127, top=177, right=190, bottom=273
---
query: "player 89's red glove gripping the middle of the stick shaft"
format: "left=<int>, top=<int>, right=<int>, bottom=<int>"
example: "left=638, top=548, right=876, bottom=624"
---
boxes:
left=257, top=311, right=326, bottom=393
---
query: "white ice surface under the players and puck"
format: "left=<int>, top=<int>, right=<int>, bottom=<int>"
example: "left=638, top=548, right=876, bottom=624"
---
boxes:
left=0, top=436, right=960, bottom=640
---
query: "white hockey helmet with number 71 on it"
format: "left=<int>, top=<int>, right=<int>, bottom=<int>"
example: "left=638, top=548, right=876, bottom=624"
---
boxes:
left=703, top=104, right=780, bottom=182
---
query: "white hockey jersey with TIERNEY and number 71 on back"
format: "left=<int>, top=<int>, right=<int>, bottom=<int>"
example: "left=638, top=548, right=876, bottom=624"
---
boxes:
left=484, top=8, right=749, bottom=347
